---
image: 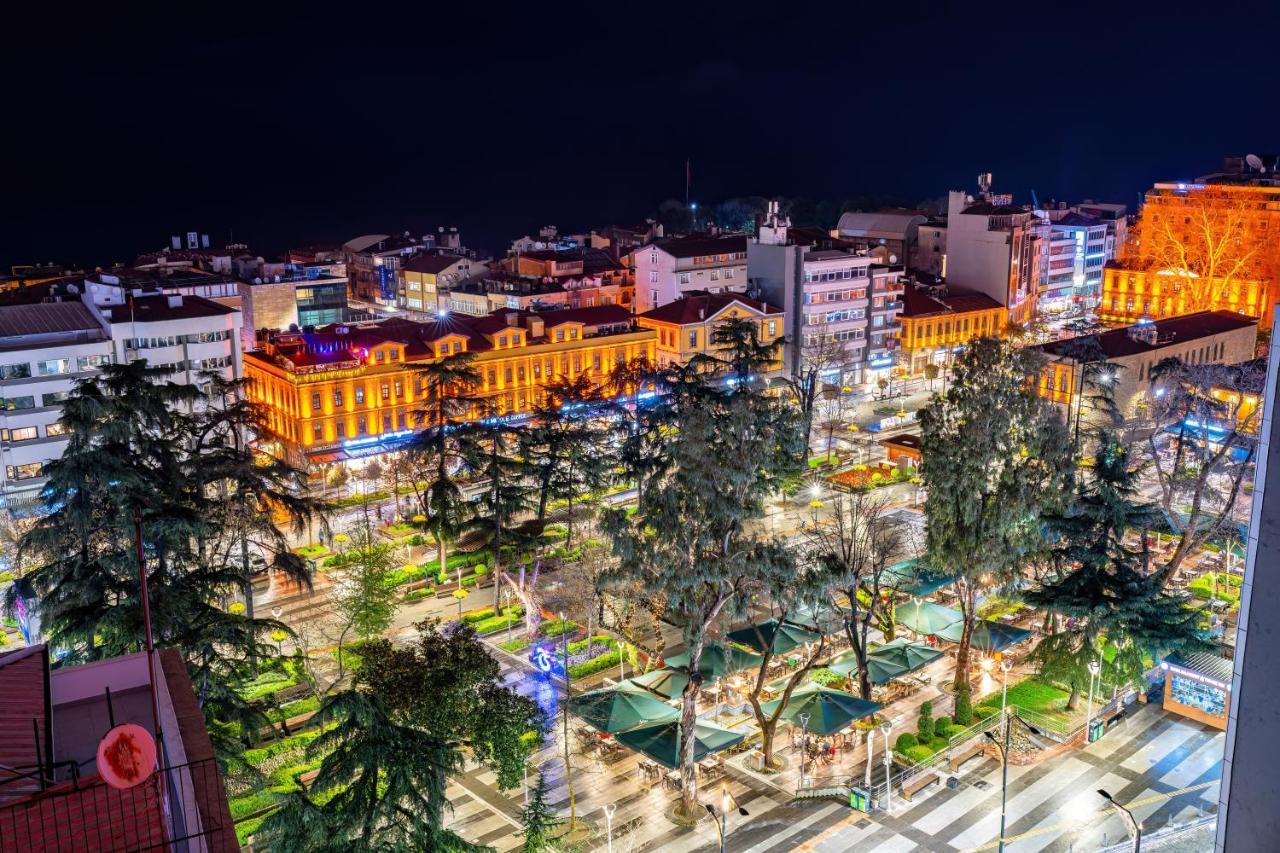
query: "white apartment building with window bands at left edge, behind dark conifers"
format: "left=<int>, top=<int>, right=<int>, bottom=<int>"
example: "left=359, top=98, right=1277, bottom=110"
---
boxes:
left=0, top=288, right=243, bottom=510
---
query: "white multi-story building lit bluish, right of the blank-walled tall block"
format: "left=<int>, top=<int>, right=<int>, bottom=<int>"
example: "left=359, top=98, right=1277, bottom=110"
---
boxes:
left=1036, top=209, right=1114, bottom=314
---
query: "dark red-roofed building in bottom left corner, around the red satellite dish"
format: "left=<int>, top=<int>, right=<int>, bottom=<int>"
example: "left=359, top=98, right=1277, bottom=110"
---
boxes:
left=0, top=646, right=239, bottom=853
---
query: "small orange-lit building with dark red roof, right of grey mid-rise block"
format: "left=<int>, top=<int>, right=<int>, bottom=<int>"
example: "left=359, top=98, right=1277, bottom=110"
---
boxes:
left=899, top=287, right=1006, bottom=377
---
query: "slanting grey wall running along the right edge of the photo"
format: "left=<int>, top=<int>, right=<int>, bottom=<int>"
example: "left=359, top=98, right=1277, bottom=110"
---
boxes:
left=1216, top=327, right=1280, bottom=853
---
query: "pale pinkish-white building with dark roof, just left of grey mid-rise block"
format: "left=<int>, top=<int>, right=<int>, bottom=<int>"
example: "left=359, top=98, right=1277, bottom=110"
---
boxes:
left=634, top=234, right=748, bottom=314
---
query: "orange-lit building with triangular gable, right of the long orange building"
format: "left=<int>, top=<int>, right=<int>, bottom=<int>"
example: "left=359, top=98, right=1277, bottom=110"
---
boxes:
left=636, top=291, right=785, bottom=373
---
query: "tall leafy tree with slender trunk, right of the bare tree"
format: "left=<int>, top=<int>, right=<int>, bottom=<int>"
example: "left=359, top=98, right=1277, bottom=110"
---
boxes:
left=919, top=338, right=1071, bottom=688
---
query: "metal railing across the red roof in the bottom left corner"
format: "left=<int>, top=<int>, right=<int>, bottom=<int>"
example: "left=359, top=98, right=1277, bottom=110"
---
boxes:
left=0, top=758, right=232, bottom=853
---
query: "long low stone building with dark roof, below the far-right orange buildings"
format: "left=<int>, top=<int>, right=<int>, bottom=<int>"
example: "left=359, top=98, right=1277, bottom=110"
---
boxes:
left=1038, top=311, right=1258, bottom=423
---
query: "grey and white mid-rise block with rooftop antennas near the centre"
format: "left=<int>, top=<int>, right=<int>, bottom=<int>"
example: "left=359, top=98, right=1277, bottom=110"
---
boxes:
left=748, top=202, right=902, bottom=386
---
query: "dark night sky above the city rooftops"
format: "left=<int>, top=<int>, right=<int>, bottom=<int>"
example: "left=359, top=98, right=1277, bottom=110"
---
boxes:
left=0, top=0, right=1280, bottom=269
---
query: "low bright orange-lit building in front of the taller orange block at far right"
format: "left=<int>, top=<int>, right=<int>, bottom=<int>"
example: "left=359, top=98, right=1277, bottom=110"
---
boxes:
left=1097, top=265, right=1275, bottom=328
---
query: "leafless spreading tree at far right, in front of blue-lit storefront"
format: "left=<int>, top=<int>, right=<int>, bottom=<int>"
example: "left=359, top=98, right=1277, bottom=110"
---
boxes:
left=1147, top=359, right=1266, bottom=581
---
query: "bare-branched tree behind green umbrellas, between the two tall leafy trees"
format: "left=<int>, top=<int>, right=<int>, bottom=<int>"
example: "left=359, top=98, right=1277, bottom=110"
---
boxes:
left=804, top=493, right=908, bottom=699
